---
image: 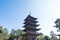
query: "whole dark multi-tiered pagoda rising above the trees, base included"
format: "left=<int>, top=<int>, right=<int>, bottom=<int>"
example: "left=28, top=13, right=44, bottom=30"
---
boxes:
left=23, top=15, right=41, bottom=40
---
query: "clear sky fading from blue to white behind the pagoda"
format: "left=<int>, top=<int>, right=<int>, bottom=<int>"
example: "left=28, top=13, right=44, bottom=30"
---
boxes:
left=0, top=0, right=60, bottom=35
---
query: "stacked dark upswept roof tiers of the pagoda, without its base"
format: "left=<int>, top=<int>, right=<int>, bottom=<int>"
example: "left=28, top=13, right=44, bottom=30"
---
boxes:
left=23, top=15, right=40, bottom=35
